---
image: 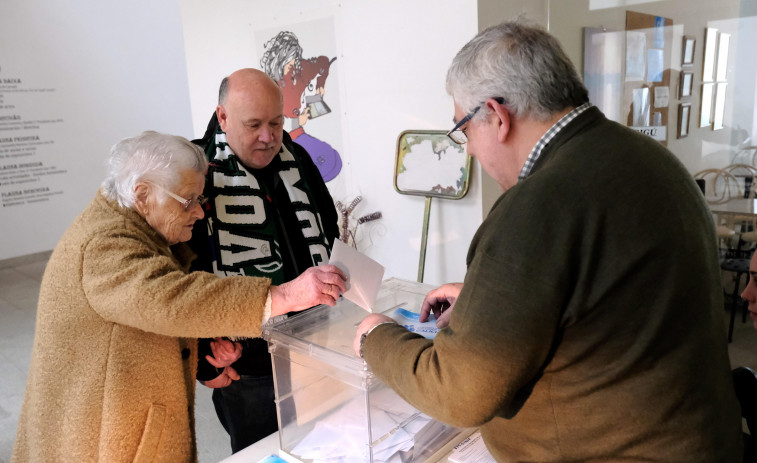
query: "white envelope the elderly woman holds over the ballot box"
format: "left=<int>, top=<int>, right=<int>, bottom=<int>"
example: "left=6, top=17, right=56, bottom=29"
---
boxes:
left=329, top=240, right=385, bottom=312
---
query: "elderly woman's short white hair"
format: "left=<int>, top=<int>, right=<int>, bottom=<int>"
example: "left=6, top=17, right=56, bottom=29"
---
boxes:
left=102, top=131, right=208, bottom=208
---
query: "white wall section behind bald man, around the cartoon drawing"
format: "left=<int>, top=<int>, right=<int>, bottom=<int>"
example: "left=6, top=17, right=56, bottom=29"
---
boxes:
left=181, top=0, right=481, bottom=283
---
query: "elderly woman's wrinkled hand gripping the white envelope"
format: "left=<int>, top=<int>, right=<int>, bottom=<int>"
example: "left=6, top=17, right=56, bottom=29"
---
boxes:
left=271, top=265, right=347, bottom=317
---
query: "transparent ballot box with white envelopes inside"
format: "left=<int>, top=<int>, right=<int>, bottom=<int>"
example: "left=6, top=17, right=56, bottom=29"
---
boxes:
left=264, top=278, right=464, bottom=463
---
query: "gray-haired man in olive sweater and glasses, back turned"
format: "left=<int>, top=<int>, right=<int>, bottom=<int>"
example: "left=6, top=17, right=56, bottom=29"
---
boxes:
left=355, top=23, right=741, bottom=462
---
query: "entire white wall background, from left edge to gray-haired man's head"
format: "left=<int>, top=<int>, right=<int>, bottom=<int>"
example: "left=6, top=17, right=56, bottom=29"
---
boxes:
left=0, top=0, right=481, bottom=283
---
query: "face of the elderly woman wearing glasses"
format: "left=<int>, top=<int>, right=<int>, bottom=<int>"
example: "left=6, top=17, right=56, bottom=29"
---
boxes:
left=138, top=170, right=205, bottom=245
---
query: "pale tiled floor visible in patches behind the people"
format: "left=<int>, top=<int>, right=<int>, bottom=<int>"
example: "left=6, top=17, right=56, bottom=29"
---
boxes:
left=0, top=254, right=757, bottom=463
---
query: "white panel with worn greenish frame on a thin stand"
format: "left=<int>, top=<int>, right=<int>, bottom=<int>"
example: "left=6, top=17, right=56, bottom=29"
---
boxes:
left=394, top=130, right=471, bottom=199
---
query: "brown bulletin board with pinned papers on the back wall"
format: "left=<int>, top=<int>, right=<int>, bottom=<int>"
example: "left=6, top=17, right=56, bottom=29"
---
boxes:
left=623, top=11, right=675, bottom=145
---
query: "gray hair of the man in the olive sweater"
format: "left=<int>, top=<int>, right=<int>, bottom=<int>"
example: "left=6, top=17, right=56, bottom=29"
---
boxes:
left=447, top=21, right=589, bottom=121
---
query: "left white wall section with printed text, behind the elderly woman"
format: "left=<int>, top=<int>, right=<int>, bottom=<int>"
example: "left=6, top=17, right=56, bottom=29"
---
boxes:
left=0, top=0, right=192, bottom=259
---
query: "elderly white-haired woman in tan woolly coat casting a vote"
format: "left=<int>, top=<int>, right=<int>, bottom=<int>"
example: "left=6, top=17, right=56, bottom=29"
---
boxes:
left=12, top=132, right=346, bottom=462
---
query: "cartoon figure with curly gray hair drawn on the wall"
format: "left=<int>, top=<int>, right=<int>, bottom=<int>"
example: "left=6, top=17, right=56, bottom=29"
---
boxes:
left=260, top=31, right=342, bottom=182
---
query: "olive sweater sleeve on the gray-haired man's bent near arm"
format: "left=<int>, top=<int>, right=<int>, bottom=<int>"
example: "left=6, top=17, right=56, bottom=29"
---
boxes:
left=365, top=188, right=570, bottom=426
